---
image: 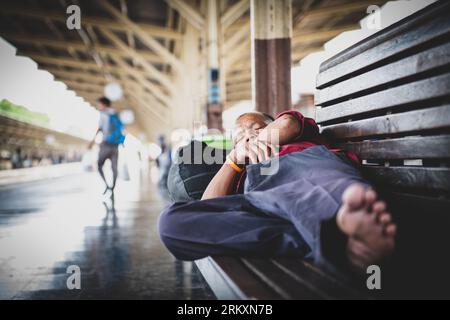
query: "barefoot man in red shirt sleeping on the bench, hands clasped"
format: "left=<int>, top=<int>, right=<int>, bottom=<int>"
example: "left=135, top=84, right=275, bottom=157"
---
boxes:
left=159, top=111, right=396, bottom=271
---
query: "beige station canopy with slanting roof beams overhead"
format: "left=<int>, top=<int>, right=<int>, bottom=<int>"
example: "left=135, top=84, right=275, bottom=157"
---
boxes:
left=0, top=0, right=386, bottom=137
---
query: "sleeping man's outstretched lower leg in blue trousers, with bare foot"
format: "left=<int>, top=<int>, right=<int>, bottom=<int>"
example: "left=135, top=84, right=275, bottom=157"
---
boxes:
left=245, top=170, right=396, bottom=270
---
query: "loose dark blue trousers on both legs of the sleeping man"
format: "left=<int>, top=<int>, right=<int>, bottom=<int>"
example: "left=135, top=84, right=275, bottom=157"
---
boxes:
left=159, top=146, right=368, bottom=263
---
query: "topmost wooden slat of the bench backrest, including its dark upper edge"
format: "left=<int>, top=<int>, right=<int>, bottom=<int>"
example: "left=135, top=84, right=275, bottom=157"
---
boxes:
left=317, top=1, right=450, bottom=89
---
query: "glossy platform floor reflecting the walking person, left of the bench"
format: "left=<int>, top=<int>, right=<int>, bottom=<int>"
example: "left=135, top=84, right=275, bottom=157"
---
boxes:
left=0, top=170, right=214, bottom=299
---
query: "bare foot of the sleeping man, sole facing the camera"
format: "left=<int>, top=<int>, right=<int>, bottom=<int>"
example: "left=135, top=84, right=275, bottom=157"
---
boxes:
left=336, top=184, right=397, bottom=271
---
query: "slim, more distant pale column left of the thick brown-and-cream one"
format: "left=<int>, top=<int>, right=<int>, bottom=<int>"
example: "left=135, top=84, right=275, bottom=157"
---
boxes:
left=206, top=0, right=223, bottom=131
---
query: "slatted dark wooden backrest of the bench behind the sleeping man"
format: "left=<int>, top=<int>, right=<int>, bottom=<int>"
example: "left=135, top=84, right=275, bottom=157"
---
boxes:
left=316, top=1, right=450, bottom=296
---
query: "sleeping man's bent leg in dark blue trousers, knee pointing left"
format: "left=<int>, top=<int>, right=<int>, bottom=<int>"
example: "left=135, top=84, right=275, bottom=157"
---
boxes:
left=159, top=195, right=311, bottom=260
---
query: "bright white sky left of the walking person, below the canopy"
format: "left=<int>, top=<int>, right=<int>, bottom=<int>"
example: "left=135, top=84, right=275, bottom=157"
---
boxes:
left=0, top=38, right=98, bottom=139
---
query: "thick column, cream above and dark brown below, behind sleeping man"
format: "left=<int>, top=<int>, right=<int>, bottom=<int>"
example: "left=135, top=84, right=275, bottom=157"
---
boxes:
left=250, top=0, right=292, bottom=115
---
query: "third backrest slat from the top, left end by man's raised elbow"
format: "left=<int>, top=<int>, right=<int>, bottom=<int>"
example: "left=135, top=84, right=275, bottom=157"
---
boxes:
left=316, top=73, right=450, bottom=123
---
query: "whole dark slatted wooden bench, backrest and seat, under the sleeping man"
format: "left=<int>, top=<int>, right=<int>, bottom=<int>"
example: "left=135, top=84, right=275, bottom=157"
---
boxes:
left=197, top=1, right=450, bottom=299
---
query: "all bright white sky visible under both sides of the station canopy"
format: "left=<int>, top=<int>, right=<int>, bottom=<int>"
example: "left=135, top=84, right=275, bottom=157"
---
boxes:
left=0, top=0, right=435, bottom=138
